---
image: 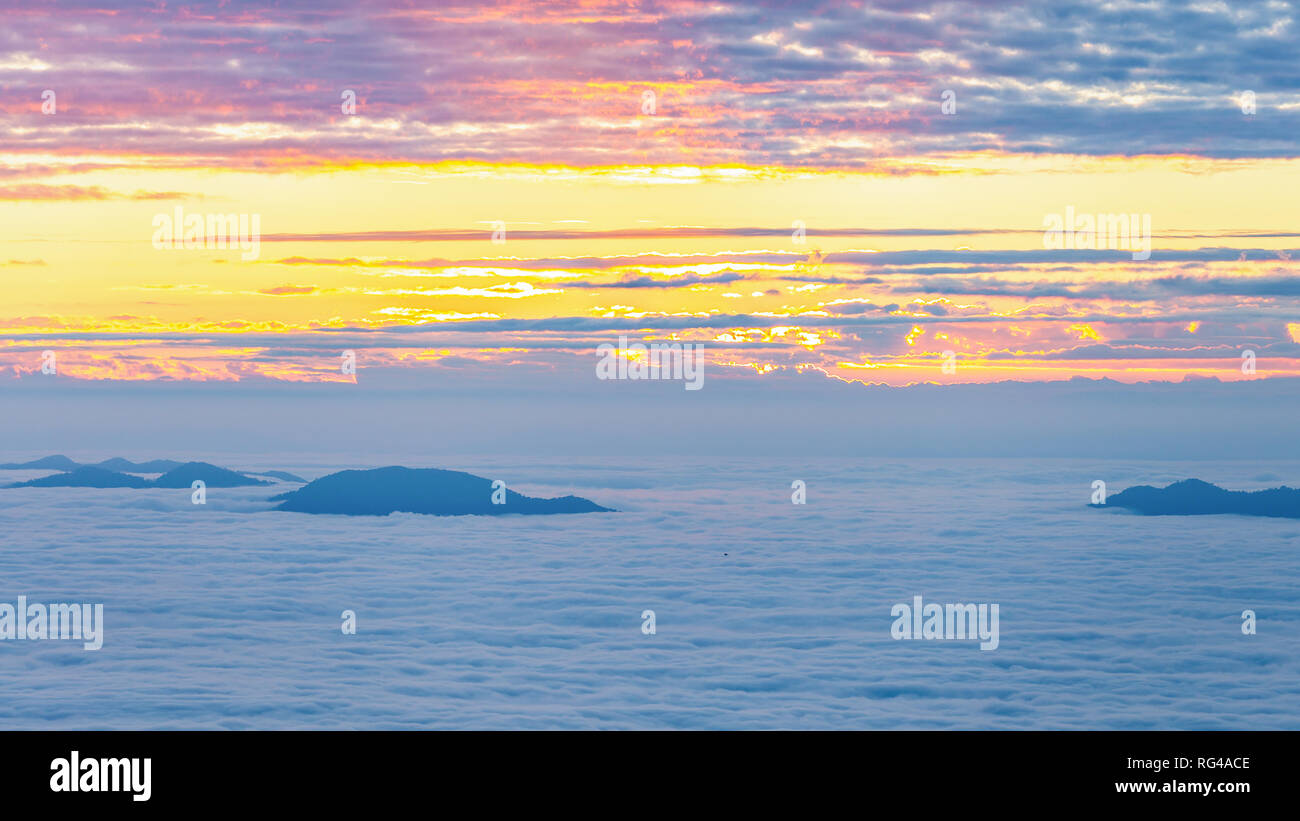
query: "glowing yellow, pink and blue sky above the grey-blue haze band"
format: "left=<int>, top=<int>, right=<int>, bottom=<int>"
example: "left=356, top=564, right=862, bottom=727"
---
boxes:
left=0, top=0, right=1300, bottom=452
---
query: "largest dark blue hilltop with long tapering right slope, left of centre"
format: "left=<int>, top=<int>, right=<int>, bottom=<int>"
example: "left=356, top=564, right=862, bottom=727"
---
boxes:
left=272, top=468, right=610, bottom=516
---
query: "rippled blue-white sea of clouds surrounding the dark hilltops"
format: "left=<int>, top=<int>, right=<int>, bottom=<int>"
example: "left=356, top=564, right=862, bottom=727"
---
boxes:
left=0, top=453, right=1300, bottom=729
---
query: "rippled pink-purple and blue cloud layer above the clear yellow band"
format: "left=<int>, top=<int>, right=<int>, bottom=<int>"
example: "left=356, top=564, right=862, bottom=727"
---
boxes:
left=0, top=0, right=1300, bottom=166
